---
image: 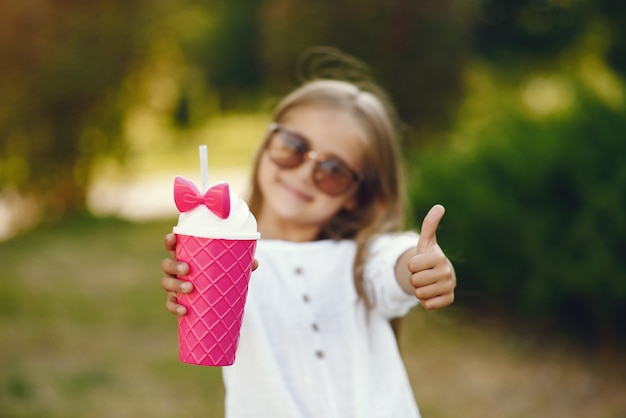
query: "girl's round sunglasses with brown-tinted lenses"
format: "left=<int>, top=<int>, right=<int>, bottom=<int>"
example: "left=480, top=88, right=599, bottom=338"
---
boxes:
left=265, top=123, right=361, bottom=195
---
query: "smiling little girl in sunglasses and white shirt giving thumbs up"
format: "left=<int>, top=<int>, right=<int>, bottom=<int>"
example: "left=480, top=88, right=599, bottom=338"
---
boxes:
left=161, top=80, right=456, bottom=418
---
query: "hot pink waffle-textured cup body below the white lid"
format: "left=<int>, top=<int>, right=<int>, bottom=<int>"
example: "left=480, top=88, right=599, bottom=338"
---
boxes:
left=176, top=234, right=256, bottom=366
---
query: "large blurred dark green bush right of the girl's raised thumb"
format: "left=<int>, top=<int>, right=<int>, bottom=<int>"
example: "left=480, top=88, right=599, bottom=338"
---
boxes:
left=410, top=92, right=626, bottom=341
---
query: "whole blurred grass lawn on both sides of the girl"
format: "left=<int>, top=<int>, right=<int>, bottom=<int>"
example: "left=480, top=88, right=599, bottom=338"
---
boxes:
left=0, top=214, right=626, bottom=418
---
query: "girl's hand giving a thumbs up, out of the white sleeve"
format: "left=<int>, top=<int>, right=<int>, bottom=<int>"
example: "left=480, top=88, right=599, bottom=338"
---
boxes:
left=396, top=205, right=456, bottom=309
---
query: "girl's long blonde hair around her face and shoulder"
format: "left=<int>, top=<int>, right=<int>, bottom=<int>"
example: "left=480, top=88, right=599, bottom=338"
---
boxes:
left=249, top=80, right=406, bottom=309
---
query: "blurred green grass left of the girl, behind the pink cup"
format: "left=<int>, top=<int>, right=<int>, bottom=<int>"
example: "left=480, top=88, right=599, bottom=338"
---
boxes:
left=0, top=219, right=224, bottom=417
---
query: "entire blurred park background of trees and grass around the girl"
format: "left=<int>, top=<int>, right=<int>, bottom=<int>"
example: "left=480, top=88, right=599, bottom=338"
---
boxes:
left=0, top=0, right=626, bottom=417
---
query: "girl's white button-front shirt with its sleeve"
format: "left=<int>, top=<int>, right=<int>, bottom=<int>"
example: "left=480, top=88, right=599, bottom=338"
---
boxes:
left=223, top=234, right=419, bottom=418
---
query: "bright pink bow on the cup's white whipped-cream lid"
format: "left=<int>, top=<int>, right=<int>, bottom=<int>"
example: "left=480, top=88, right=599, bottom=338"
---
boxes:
left=174, top=176, right=230, bottom=219
